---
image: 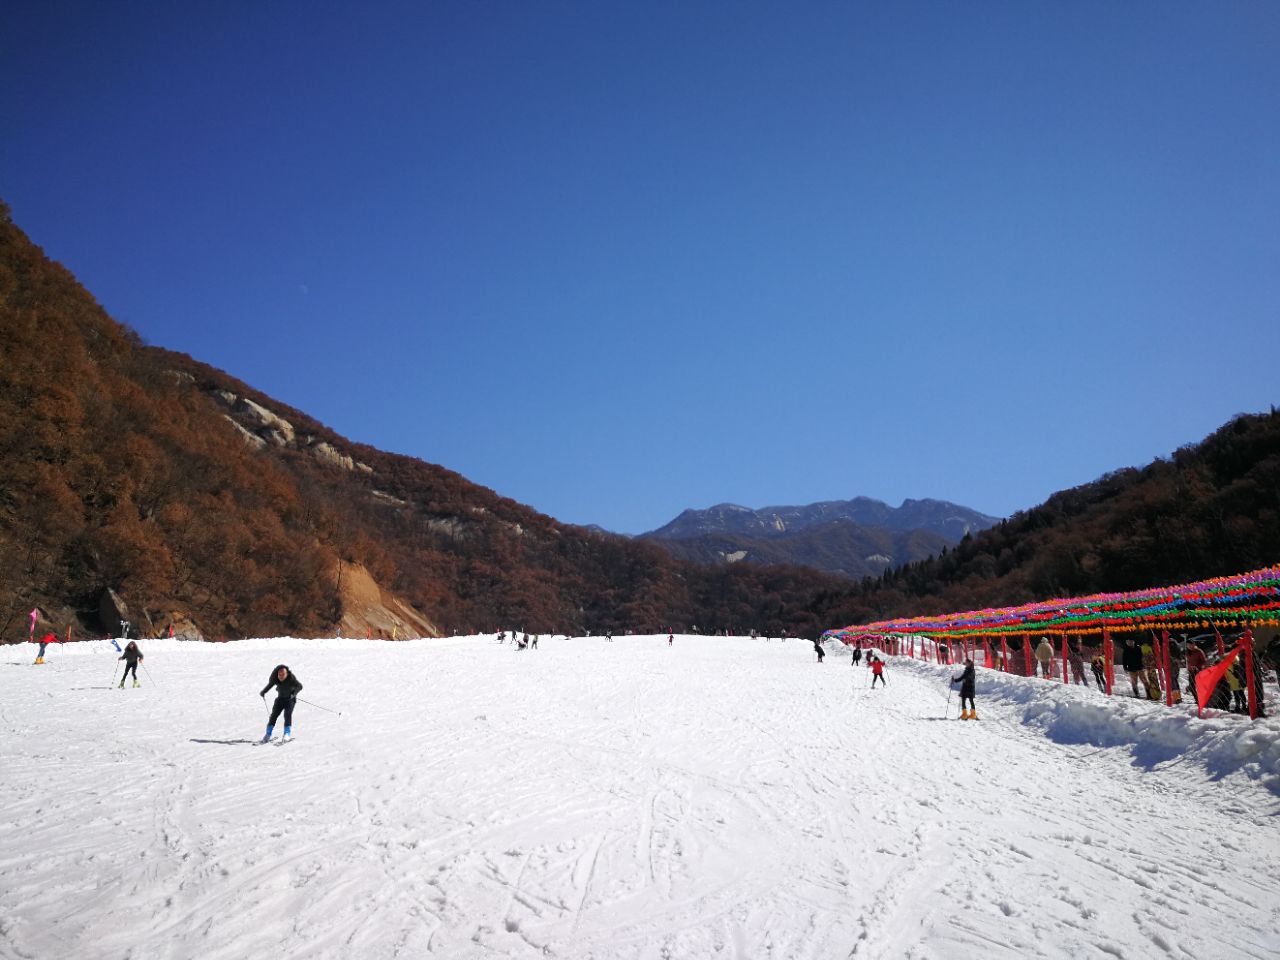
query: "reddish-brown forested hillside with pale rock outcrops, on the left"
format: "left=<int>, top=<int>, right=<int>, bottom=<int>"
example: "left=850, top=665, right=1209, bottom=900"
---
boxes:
left=0, top=207, right=855, bottom=639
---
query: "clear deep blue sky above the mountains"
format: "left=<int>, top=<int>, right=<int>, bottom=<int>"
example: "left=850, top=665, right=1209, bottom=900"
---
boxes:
left=0, top=0, right=1280, bottom=532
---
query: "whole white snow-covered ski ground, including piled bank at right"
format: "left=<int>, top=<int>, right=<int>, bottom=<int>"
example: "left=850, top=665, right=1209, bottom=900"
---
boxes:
left=0, top=636, right=1280, bottom=960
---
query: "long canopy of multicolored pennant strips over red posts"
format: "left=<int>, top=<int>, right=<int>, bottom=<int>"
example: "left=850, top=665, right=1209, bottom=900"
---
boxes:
left=824, top=566, right=1280, bottom=640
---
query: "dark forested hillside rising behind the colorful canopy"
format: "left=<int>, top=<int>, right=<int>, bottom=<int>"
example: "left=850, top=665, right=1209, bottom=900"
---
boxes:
left=829, top=407, right=1280, bottom=622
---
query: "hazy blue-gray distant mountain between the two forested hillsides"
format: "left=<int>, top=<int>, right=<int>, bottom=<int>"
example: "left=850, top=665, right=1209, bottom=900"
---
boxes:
left=641, top=497, right=1000, bottom=579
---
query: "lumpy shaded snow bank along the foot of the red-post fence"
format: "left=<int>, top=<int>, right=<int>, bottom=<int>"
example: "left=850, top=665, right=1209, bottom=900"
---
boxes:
left=893, top=657, right=1280, bottom=795
